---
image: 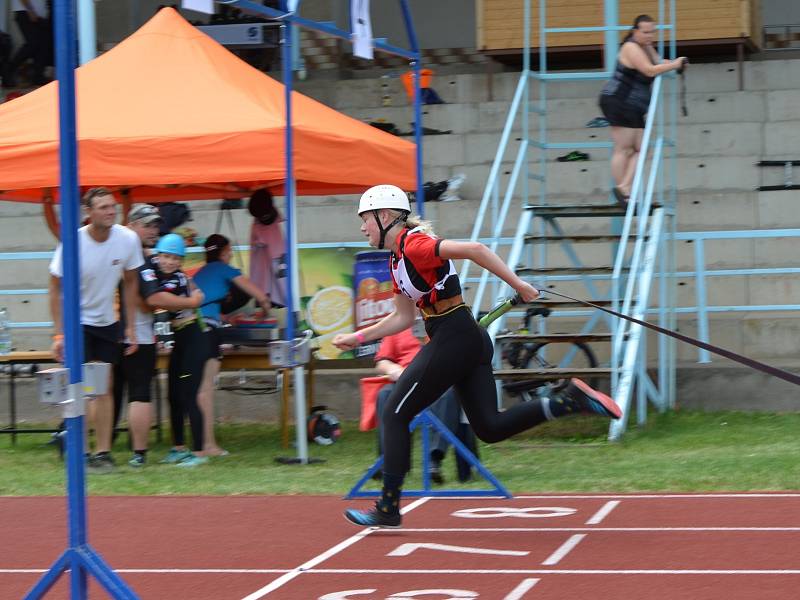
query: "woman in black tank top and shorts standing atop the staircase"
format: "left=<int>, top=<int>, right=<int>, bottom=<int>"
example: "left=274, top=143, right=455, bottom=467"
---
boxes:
left=600, top=15, right=687, bottom=204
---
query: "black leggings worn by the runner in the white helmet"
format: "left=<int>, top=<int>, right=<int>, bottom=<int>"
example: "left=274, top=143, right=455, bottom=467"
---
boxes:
left=381, top=306, right=546, bottom=476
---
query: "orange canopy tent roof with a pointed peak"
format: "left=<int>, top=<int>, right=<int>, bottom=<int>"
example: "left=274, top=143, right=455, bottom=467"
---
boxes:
left=0, top=8, right=415, bottom=203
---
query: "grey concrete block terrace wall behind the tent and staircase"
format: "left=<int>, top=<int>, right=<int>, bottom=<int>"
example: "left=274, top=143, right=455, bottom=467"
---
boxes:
left=0, top=60, right=800, bottom=366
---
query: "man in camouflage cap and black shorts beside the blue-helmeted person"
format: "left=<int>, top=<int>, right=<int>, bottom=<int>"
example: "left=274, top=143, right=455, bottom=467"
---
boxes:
left=120, top=204, right=203, bottom=467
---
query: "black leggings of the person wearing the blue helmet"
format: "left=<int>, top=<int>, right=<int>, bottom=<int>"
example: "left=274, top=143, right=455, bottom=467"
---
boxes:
left=168, top=321, right=208, bottom=452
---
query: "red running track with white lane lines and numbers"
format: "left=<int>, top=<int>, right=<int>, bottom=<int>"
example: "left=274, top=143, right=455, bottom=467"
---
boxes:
left=0, top=493, right=800, bottom=600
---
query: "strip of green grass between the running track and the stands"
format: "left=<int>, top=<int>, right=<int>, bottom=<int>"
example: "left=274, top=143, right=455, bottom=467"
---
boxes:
left=0, top=412, right=800, bottom=496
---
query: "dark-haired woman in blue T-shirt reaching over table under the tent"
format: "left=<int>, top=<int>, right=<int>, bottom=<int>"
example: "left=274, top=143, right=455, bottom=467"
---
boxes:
left=194, top=233, right=271, bottom=456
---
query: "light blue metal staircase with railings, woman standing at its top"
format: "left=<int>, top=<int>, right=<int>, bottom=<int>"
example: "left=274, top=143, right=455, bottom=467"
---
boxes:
left=461, top=0, right=677, bottom=440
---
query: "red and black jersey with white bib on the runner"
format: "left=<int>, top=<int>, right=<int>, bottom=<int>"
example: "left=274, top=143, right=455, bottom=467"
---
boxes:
left=390, top=228, right=461, bottom=308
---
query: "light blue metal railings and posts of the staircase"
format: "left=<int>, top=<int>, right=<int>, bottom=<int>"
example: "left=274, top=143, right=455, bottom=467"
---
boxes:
left=461, top=0, right=677, bottom=439
